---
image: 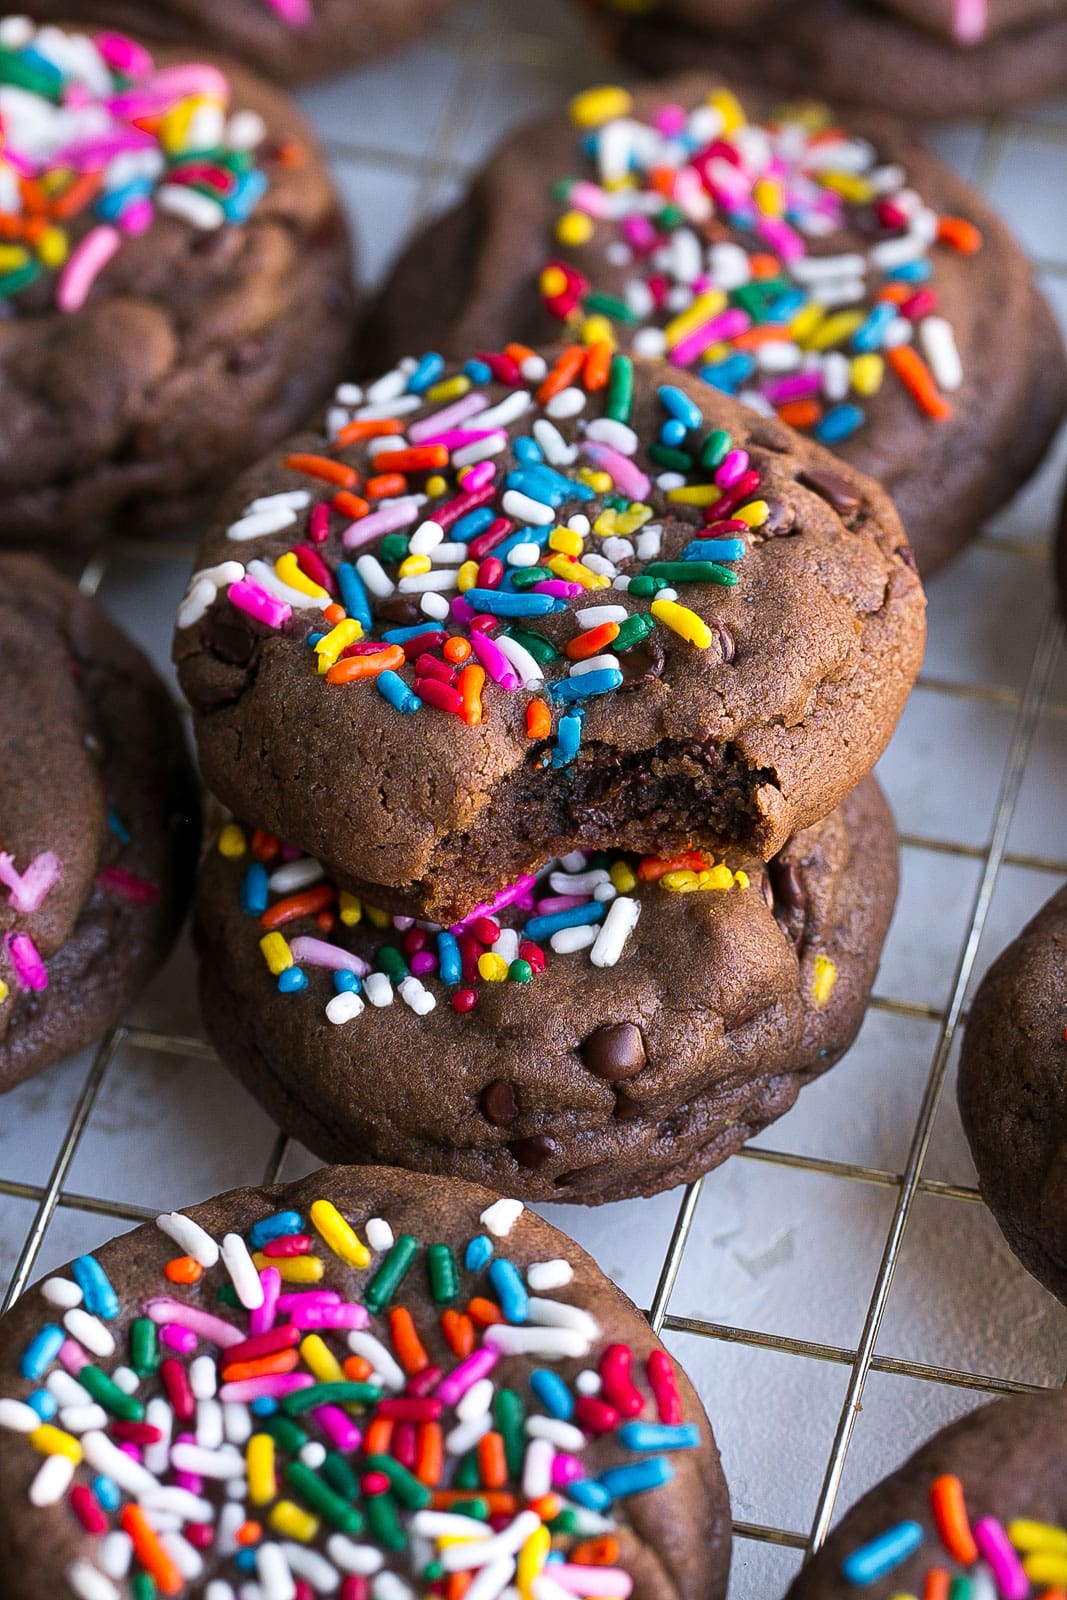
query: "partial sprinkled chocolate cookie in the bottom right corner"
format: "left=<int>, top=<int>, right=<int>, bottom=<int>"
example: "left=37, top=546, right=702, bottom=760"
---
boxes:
left=787, top=1390, right=1067, bottom=1600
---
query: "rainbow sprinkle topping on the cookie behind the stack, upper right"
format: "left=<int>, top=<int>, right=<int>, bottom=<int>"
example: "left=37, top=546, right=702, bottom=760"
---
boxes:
left=539, top=86, right=981, bottom=445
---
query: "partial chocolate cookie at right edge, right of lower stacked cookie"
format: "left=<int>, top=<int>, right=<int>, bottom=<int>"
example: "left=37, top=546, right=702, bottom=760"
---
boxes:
left=958, top=888, right=1067, bottom=1302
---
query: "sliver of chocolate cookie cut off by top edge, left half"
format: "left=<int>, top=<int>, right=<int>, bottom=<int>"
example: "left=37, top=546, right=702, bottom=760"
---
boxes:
left=24, top=0, right=451, bottom=82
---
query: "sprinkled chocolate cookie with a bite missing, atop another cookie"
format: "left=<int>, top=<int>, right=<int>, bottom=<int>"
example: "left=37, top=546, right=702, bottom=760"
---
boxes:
left=174, top=344, right=925, bottom=923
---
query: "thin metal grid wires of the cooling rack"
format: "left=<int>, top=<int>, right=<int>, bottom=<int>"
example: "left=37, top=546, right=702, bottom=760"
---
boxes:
left=0, top=6, right=1067, bottom=1593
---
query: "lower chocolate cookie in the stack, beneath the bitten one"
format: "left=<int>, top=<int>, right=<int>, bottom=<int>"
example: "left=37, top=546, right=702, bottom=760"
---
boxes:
left=197, top=778, right=897, bottom=1203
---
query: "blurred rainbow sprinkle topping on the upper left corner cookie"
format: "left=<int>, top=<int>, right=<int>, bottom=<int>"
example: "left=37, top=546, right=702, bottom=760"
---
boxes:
left=0, top=16, right=275, bottom=312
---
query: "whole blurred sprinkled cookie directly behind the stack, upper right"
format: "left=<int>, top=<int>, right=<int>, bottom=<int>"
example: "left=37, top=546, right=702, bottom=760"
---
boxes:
left=365, top=78, right=1067, bottom=573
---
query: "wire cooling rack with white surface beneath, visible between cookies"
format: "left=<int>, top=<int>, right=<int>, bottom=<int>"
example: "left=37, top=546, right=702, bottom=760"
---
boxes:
left=0, top=0, right=1067, bottom=1600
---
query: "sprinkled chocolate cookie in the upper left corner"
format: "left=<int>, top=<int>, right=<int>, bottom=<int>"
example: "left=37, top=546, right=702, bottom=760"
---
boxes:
left=0, top=17, right=354, bottom=544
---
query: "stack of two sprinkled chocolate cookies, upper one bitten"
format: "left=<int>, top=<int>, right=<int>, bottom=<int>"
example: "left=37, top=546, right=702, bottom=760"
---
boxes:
left=176, top=341, right=925, bottom=1202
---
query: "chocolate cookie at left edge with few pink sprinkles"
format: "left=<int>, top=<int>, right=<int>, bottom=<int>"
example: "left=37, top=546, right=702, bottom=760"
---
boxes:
left=0, top=555, right=200, bottom=1091
